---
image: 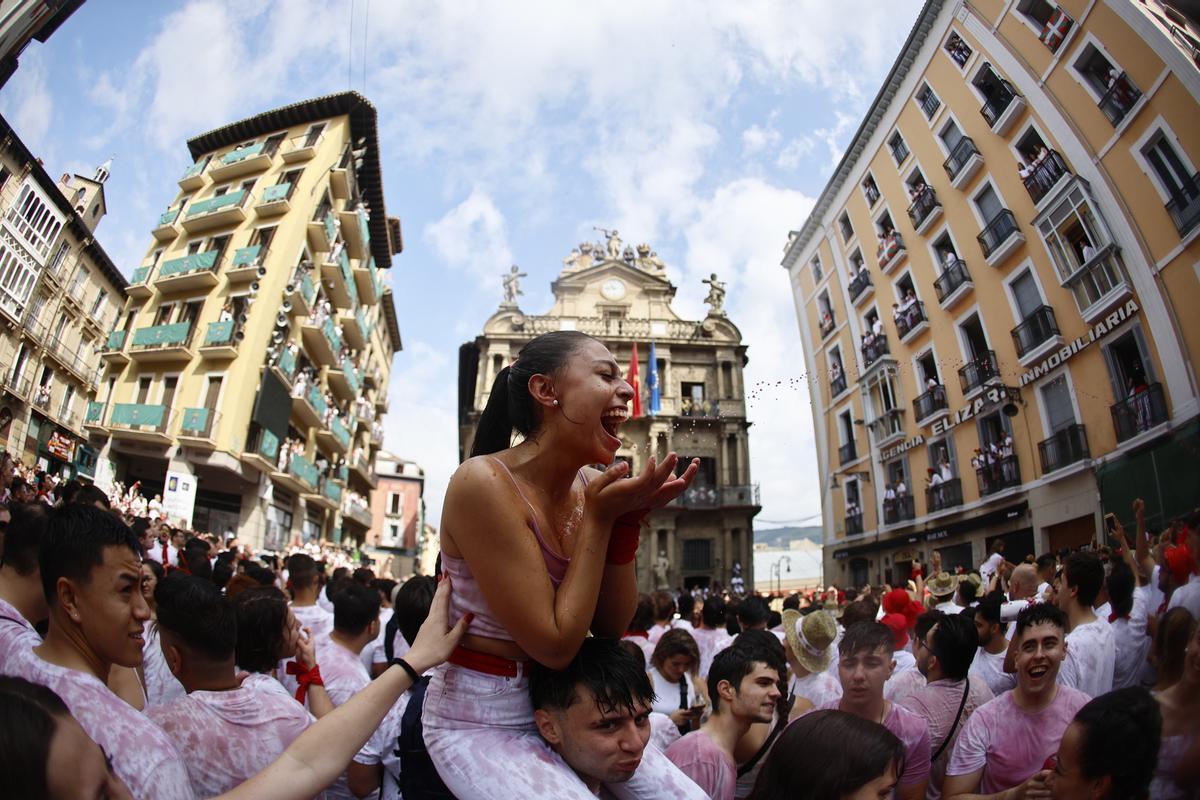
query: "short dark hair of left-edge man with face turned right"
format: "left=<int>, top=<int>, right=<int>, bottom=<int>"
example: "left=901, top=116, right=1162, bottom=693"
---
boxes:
left=37, top=505, right=142, bottom=608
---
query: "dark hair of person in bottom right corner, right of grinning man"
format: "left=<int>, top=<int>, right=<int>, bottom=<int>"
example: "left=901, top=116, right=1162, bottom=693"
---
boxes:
left=1074, top=686, right=1163, bottom=800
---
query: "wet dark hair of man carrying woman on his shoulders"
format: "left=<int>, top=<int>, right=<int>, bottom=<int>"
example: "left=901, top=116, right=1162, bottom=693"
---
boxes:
left=529, top=637, right=654, bottom=715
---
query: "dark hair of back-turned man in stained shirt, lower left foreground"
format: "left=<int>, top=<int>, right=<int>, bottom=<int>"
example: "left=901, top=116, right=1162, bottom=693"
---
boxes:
left=154, top=572, right=238, bottom=662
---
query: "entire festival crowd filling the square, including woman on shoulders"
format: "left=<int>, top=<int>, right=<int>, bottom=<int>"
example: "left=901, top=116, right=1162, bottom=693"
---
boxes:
left=0, top=332, right=1200, bottom=800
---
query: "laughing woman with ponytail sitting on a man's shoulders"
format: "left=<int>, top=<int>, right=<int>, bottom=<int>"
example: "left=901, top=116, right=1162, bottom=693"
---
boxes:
left=422, top=331, right=704, bottom=800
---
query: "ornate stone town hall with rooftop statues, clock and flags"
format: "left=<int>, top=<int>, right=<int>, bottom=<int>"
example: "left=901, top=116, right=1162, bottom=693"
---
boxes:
left=458, top=239, right=761, bottom=591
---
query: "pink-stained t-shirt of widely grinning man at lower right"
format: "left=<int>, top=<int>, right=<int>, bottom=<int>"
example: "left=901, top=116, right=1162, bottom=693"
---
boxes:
left=946, top=685, right=1092, bottom=794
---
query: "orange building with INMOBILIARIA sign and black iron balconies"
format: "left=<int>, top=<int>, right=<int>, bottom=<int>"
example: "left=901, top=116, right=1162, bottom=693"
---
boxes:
left=784, top=0, right=1200, bottom=585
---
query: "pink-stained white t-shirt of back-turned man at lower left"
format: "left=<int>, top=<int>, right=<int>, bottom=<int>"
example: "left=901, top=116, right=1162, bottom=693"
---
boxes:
left=146, top=675, right=312, bottom=798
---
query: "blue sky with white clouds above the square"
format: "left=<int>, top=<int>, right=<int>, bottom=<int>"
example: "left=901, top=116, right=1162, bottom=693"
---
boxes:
left=0, top=0, right=920, bottom=528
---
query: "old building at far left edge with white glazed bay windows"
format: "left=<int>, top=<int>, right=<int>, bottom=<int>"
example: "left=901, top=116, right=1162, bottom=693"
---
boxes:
left=0, top=112, right=126, bottom=479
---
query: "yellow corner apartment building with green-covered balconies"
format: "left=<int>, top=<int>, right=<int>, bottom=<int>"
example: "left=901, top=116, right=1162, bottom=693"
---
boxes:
left=85, top=92, right=401, bottom=548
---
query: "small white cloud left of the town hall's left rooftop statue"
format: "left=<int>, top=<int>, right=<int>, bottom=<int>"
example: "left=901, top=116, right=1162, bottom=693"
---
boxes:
left=425, top=186, right=512, bottom=284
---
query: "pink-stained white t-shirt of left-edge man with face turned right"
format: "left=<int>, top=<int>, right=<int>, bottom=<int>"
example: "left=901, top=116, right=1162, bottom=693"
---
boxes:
left=2, top=650, right=194, bottom=800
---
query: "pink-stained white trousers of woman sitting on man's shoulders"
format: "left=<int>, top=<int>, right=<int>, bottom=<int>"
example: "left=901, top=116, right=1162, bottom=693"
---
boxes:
left=421, top=663, right=708, bottom=800
